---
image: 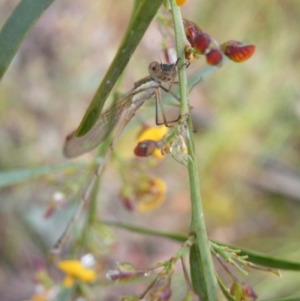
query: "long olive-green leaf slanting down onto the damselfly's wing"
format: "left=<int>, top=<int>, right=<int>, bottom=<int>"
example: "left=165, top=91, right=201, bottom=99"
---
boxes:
left=76, top=0, right=163, bottom=136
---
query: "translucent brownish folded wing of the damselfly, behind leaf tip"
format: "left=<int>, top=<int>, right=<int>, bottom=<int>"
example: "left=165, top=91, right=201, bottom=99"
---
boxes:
left=63, top=91, right=133, bottom=158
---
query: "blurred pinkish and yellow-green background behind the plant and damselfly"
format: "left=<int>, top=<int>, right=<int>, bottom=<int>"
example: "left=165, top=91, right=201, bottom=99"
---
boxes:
left=0, top=0, right=300, bottom=300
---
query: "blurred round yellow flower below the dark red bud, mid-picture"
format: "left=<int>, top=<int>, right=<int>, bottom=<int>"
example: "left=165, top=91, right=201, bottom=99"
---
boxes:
left=137, top=178, right=167, bottom=212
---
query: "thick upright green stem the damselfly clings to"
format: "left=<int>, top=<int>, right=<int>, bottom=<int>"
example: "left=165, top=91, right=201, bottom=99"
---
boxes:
left=170, top=0, right=218, bottom=301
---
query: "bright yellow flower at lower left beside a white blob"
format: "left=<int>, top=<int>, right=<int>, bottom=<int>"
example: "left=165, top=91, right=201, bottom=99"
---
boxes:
left=57, top=260, right=96, bottom=287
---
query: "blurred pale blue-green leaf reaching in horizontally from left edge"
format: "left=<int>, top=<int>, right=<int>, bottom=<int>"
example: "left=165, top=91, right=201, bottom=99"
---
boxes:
left=0, top=163, right=83, bottom=187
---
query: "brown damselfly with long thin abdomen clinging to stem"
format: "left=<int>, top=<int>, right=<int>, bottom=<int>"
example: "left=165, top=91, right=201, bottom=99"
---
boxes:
left=53, top=62, right=180, bottom=253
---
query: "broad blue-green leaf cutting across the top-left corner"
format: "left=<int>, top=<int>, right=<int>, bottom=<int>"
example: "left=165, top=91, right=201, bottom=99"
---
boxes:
left=0, top=0, right=54, bottom=79
